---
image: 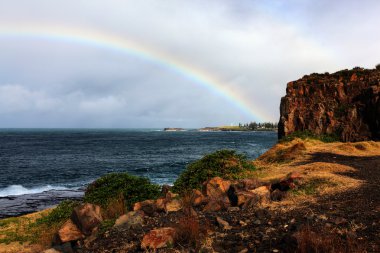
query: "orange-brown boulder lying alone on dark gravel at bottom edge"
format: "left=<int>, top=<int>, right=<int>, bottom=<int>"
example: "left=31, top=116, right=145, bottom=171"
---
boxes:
left=141, top=227, right=176, bottom=250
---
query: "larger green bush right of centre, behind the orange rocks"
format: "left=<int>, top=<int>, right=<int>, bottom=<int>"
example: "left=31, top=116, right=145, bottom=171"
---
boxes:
left=173, top=150, right=255, bottom=193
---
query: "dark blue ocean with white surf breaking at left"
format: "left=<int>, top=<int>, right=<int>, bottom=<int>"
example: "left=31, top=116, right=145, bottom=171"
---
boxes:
left=0, top=129, right=277, bottom=218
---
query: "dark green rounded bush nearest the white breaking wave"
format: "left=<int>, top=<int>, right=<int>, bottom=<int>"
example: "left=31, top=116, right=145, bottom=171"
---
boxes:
left=84, top=173, right=160, bottom=209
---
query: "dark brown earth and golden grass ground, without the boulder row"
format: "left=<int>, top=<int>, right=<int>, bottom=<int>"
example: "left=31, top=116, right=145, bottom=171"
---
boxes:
left=0, top=139, right=380, bottom=252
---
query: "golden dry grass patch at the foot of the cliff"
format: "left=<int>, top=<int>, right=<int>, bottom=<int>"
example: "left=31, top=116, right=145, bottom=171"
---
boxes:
left=254, top=139, right=380, bottom=208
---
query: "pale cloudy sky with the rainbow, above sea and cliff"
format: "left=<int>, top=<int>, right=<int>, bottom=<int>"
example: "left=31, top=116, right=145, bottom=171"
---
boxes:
left=0, top=0, right=380, bottom=128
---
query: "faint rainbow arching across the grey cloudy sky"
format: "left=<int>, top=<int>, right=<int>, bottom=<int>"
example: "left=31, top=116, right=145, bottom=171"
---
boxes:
left=0, top=25, right=271, bottom=121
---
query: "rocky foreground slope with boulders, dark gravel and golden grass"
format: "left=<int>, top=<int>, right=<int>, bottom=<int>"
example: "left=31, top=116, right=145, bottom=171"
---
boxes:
left=0, top=140, right=380, bottom=253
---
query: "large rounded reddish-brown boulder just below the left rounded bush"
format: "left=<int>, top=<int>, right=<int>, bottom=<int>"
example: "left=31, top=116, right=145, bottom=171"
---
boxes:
left=71, top=203, right=103, bottom=235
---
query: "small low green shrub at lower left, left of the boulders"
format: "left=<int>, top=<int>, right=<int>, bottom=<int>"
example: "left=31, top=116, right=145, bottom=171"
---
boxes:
left=34, top=200, right=79, bottom=226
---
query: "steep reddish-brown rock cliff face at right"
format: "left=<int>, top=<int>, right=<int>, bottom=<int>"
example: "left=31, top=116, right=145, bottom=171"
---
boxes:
left=278, top=68, right=380, bottom=141
